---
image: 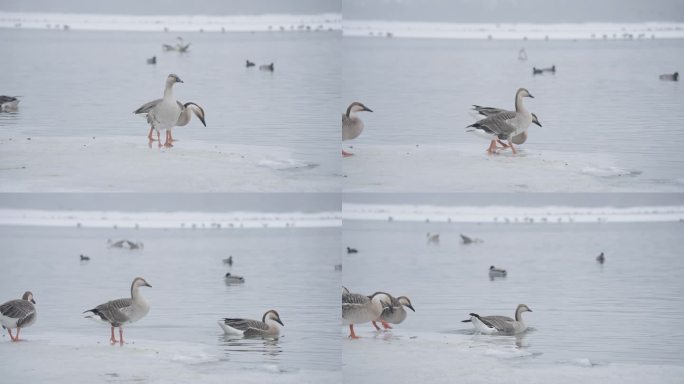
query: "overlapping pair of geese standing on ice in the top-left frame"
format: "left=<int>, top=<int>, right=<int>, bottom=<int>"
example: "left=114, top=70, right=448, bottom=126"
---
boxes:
left=133, top=73, right=207, bottom=148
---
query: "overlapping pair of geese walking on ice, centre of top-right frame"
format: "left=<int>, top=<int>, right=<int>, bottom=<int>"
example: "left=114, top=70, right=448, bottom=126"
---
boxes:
left=466, top=88, right=542, bottom=155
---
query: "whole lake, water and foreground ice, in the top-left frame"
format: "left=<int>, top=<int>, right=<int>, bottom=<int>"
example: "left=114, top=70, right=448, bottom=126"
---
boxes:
left=0, top=29, right=341, bottom=191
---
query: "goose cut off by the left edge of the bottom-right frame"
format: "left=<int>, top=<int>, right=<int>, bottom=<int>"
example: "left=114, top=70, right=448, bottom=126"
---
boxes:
left=342, top=287, right=392, bottom=339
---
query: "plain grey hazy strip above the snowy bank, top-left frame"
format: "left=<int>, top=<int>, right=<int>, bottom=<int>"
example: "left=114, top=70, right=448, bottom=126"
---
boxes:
left=0, top=0, right=340, bottom=15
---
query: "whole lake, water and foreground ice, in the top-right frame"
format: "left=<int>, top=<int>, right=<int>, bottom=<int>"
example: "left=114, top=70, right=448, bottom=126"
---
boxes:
left=340, top=37, right=684, bottom=192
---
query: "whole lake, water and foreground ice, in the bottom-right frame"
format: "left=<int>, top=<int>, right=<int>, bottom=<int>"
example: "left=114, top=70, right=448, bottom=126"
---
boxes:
left=340, top=220, right=684, bottom=383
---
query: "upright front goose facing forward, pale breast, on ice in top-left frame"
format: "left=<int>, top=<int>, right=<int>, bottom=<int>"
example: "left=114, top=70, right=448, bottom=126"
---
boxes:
left=133, top=73, right=183, bottom=148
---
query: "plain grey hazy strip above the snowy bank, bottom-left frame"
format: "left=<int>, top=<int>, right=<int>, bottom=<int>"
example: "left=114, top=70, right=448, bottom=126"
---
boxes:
left=0, top=193, right=341, bottom=213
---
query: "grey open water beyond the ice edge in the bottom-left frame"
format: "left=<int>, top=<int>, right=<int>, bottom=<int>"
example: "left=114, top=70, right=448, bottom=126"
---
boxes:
left=0, top=227, right=341, bottom=371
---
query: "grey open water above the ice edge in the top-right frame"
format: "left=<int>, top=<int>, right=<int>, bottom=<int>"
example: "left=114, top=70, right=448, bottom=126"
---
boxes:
left=342, top=38, right=684, bottom=180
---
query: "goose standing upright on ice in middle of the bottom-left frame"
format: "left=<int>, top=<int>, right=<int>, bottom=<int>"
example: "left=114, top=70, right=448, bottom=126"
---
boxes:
left=83, top=277, right=152, bottom=345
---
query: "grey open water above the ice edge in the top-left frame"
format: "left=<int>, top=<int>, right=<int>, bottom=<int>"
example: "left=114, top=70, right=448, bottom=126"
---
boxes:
left=0, top=29, right=340, bottom=161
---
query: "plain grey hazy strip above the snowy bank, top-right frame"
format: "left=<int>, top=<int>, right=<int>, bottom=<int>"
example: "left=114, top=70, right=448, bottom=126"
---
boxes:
left=342, top=0, right=684, bottom=23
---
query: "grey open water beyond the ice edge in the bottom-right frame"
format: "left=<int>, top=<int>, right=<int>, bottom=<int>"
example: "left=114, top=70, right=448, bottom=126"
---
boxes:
left=343, top=221, right=684, bottom=365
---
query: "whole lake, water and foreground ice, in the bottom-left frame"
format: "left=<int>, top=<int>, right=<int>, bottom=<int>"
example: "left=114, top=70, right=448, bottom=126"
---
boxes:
left=0, top=226, right=341, bottom=382
